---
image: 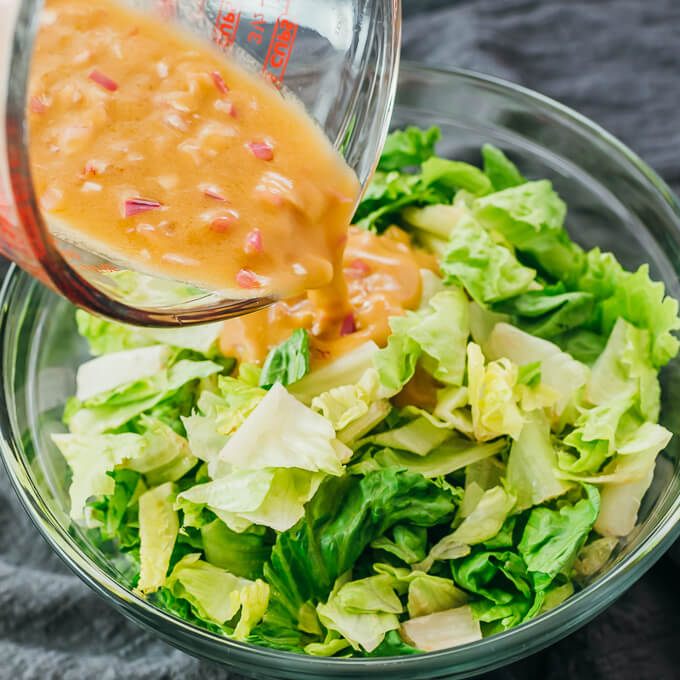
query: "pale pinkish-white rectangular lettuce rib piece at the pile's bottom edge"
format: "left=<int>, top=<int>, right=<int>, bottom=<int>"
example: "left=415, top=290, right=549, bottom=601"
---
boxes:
left=401, top=605, right=482, bottom=652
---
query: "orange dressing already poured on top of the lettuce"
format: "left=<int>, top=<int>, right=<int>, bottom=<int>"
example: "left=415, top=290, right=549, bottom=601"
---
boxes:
left=220, top=227, right=437, bottom=364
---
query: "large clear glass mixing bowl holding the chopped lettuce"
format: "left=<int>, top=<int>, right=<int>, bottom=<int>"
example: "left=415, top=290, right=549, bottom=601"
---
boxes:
left=0, top=64, right=680, bottom=680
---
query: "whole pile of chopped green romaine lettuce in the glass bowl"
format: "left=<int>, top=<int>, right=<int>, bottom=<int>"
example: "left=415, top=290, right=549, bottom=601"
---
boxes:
left=53, top=128, right=680, bottom=657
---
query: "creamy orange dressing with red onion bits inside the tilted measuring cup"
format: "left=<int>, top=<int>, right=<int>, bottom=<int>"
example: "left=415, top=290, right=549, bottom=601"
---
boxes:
left=28, top=0, right=359, bottom=300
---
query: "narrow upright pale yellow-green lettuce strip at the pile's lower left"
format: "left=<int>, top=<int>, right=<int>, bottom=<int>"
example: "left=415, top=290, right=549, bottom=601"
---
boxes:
left=137, top=482, right=179, bottom=593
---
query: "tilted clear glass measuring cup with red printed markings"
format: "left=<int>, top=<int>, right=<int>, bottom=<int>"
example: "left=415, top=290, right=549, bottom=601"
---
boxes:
left=0, top=0, right=400, bottom=326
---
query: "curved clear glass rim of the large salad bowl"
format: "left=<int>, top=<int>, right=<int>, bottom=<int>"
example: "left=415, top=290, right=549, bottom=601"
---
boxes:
left=0, top=61, right=680, bottom=677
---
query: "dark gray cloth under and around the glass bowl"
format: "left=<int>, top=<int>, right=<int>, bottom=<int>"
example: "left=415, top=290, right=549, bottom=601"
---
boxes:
left=0, top=0, right=680, bottom=680
